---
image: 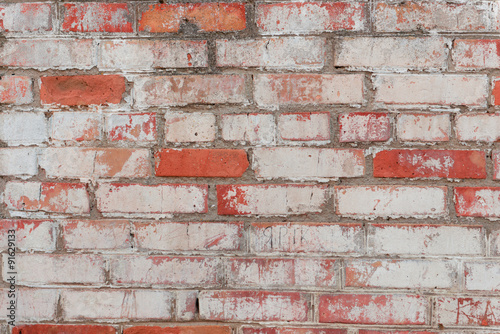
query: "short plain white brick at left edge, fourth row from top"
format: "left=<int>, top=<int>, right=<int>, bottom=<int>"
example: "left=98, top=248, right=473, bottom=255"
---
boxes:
left=0, top=112, right=48, bottom=146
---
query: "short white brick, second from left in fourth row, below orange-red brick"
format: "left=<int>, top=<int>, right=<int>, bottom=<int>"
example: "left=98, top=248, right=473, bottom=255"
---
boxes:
left=49, top=112, right=102, bottom=142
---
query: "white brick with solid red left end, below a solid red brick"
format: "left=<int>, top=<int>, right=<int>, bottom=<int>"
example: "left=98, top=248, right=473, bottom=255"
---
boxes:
left=217, top=184, right=328, bottom=215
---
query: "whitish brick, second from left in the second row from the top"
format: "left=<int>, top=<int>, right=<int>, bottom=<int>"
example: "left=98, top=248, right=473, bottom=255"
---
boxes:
left=98, top=39, right=208, bottom=71
